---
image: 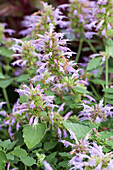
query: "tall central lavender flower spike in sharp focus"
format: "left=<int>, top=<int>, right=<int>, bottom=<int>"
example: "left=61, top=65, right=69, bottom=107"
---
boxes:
left=35, top=24, right=76, bottom=81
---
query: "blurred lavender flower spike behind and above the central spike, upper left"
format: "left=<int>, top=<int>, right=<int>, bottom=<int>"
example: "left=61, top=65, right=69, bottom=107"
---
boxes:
left=20, top=1, right=66, bottom=38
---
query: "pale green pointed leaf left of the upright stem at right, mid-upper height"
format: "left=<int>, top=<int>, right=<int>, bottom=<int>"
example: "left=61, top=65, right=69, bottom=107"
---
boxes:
left=87, top=57, right=102, bottom=71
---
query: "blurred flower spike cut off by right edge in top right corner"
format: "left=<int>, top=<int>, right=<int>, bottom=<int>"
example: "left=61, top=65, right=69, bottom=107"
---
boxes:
left=96, top=0, right=113, bottom=37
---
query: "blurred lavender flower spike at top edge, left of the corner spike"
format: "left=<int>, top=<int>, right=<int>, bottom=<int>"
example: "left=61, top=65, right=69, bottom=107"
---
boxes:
left=60, top=0, right=96, bottom=39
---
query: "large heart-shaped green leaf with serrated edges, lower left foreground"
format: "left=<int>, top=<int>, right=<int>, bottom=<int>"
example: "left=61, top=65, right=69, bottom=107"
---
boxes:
left=23, top=123, right=46, bottom=149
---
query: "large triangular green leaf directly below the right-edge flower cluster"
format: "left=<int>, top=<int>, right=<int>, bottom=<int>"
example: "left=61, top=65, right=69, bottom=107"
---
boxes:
left=63, top=121, right=92, bottom=140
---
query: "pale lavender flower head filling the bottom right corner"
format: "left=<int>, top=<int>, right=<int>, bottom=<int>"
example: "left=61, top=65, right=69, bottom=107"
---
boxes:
left=69, top=142, right=113, bottom=170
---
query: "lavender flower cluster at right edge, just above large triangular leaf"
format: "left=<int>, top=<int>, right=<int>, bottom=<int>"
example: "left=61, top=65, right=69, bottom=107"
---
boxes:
left=79, top=99, right=113, bottom=122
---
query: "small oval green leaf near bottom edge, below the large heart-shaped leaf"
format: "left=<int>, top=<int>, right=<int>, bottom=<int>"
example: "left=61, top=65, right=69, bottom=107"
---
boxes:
left=20, top=155, right=36, bottom=166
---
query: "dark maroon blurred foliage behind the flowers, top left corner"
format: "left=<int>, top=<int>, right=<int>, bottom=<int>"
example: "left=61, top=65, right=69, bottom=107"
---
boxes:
left=0, top=0, right=68, bottom=37
